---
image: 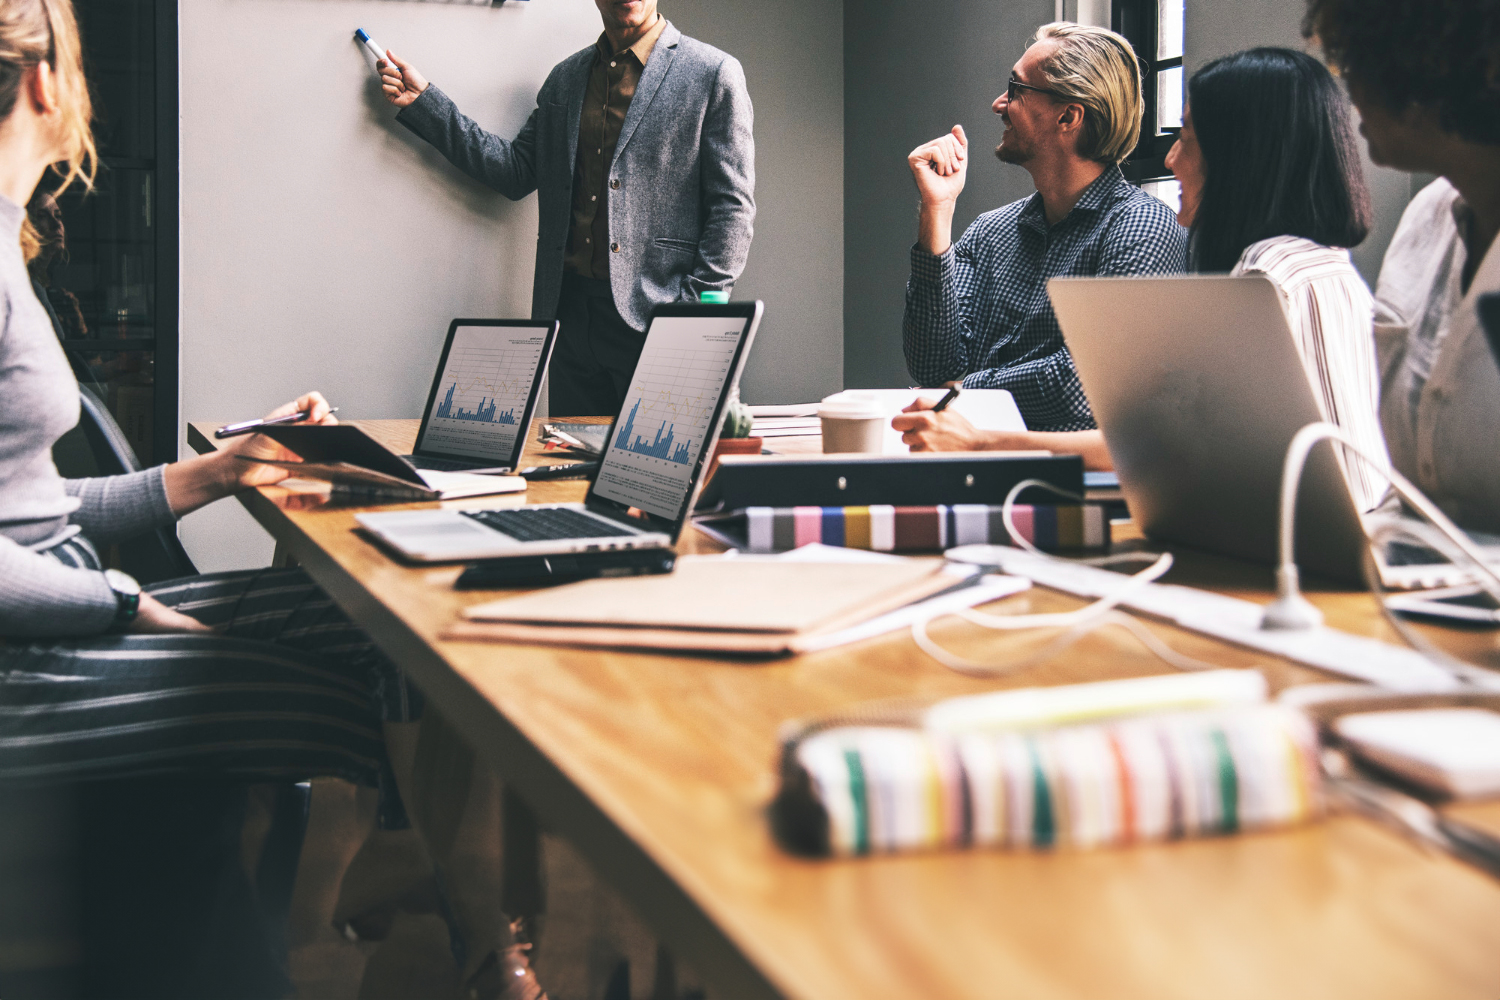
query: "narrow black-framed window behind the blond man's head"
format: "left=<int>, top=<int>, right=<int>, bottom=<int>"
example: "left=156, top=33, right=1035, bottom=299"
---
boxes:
left=1110, top=0, right=1187, bottom=207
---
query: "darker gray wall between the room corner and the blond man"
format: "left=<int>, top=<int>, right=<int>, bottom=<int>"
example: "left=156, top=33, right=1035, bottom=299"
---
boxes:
left=845, top=0, right=1053, bottom=388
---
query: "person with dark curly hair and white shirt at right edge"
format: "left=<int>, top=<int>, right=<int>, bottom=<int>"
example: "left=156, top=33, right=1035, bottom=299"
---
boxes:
left=1304, top=0, right=1500, bottom=532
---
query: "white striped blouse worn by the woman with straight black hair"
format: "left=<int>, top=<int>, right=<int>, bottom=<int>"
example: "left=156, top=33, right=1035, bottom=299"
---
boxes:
left=1233, top=235, right=1388, bottom=511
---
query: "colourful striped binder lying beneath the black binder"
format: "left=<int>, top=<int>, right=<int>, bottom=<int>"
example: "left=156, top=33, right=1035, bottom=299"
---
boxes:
left=744, top=504, right=1110, bottom=552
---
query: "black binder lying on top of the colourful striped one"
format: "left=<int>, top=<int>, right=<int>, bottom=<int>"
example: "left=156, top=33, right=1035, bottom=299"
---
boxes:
left=698, top=451, right=1083, bottom=511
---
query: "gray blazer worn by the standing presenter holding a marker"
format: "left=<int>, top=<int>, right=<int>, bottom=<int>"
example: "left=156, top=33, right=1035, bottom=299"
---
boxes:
left=396, top=22, right=755, bottom=330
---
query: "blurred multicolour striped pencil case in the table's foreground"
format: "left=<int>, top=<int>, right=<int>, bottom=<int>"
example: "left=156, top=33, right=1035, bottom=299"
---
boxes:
left=794, top=705, right=1323, bottom=855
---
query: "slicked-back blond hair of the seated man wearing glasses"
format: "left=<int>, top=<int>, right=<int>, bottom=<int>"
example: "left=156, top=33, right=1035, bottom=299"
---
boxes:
left=1032, top=21, right=1146, bottom=163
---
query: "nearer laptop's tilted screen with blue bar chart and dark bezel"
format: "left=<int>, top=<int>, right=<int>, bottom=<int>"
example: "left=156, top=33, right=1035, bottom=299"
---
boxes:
left=588, top=303, right=761, bottom=537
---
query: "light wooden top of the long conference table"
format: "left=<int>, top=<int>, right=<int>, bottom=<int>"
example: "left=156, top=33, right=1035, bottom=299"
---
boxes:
left=189, top=420, right=1500, bottom=1000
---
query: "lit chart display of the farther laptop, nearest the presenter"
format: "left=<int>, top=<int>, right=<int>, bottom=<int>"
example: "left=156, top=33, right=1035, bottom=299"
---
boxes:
left=420, top=327, right=546, bottom=459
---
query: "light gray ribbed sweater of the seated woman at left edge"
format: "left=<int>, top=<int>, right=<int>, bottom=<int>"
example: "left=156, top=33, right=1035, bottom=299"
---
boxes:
left=0, top=195, right=174, bottom=637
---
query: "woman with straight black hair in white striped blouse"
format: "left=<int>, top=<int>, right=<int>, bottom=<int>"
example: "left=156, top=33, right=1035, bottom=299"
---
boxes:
left=1167, top=48, right=1386, bottom=511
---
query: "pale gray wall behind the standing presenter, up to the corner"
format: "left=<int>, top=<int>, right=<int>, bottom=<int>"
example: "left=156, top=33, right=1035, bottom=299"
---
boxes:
left=180, top=0, right=843, bottom=570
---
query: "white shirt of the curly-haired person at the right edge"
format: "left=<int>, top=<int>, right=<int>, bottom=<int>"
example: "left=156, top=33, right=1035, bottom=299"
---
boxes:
left=1376, top=178, right=1500, bottom=532
